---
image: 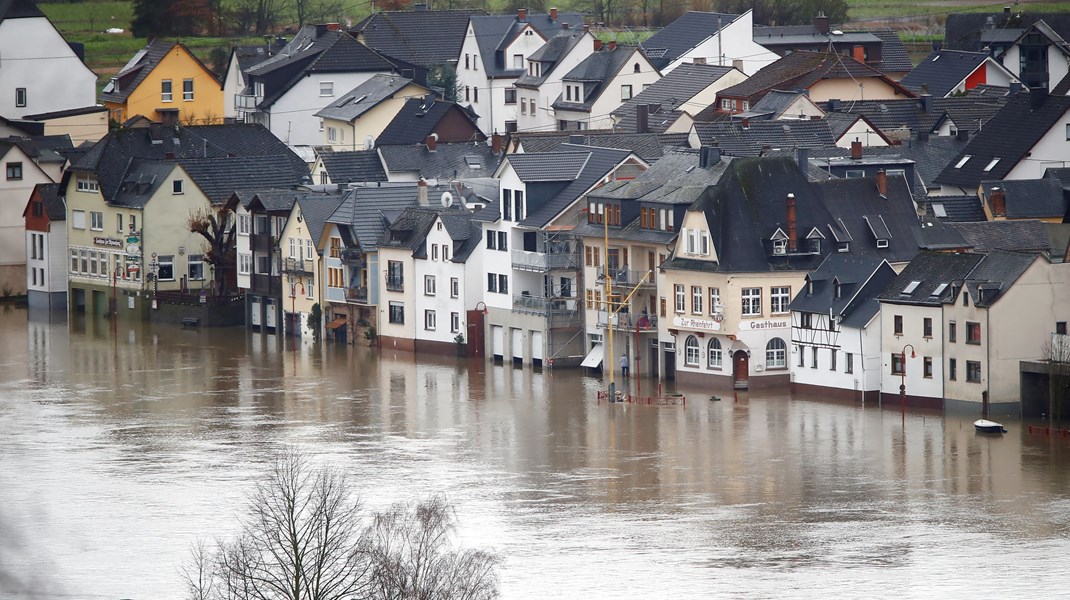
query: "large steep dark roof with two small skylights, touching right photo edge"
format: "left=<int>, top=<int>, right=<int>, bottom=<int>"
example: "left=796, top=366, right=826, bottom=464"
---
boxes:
left=935, top=94, right=1070, bottom=187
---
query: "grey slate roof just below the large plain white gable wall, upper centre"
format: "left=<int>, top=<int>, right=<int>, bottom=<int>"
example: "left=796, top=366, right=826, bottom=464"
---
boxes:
left=612, top=63, right=735, bottom=134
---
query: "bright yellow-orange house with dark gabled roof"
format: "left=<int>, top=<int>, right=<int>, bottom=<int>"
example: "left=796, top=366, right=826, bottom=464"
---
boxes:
left=101, top=40, right=223, bottom=125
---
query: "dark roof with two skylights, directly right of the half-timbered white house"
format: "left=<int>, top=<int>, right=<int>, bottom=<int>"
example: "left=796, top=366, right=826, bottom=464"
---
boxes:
left=878, top=250, right=984, bottom=306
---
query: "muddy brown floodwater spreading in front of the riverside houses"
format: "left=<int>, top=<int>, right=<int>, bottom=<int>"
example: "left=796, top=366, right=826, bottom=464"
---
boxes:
left=0, top=309, right=1070, bottom=599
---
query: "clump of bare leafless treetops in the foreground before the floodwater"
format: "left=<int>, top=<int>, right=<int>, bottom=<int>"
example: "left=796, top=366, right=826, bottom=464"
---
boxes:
left=183, top=450, right=500, bottom=600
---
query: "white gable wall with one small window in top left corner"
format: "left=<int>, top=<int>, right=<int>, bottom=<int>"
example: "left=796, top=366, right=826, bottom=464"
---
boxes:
left=0, top=17, right=96, bottom=119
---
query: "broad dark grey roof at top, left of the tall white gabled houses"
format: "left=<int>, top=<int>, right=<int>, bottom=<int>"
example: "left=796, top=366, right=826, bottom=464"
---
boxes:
left=349, top=10, right=486, bottom=67
